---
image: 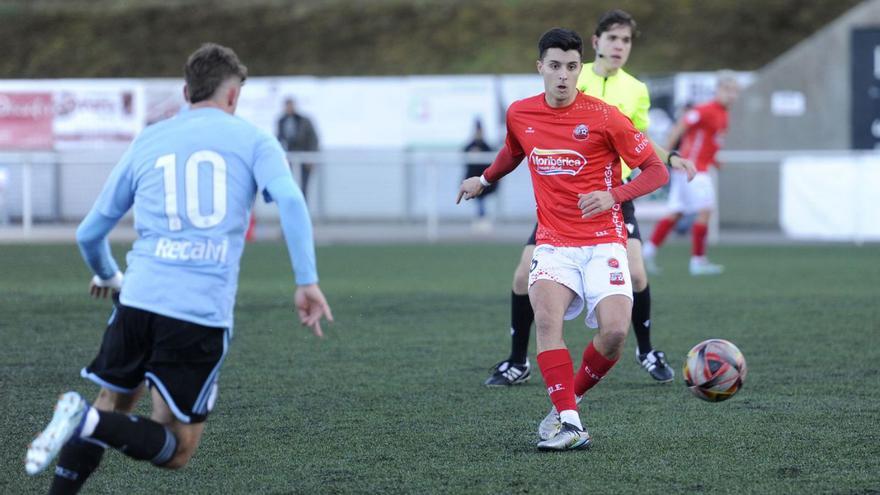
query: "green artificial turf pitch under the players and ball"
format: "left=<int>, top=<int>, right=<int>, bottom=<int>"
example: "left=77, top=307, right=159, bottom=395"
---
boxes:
left=0, top=243, right=880, bottom=494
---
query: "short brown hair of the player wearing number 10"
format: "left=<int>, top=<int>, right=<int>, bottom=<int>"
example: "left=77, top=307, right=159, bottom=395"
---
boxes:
left=183, top=43, right=247, bottom=103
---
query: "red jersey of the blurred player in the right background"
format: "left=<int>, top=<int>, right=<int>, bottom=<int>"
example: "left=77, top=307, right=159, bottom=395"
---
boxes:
left=679, top=101, right=727, bottom=172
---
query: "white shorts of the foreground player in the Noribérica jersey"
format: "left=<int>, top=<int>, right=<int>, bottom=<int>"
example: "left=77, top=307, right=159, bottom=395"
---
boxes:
left=529, top=243, right=632, bottom=328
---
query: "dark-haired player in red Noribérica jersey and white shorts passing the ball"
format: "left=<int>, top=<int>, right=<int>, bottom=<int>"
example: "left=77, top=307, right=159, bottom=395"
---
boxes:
left=457, top=28, right=668, bottom=450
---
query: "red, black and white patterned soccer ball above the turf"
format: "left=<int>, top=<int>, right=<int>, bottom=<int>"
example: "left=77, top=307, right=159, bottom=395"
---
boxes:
left=684, top=339, right=746, bottom=402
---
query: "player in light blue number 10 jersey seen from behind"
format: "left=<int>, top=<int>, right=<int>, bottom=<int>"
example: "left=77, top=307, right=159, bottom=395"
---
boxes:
left=25, top=44, right=332, bottom=493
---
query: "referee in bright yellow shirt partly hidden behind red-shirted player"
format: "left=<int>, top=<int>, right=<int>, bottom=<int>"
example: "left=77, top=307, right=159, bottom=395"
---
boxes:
left=485, top=10, right=696, bottom=386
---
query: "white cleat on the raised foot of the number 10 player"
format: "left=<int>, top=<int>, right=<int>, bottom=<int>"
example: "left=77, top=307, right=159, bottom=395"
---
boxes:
left=24, top=392, right=89, bottom=476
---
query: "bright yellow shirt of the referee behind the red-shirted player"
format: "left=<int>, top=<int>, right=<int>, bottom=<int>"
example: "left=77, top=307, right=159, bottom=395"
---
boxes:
left=577, top=63, right=651, bottom=179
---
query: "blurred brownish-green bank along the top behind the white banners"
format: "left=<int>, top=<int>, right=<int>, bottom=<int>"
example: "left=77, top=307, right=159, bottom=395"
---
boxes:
left=0, top=0, right=859, bottom=78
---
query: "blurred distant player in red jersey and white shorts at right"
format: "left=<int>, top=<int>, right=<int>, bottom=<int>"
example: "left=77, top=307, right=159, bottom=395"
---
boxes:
left=643, top=72, right=739, bottom=276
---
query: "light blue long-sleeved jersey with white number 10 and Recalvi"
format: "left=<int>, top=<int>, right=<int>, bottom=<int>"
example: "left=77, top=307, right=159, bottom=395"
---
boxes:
left=77, top=108, right=318, bottom=328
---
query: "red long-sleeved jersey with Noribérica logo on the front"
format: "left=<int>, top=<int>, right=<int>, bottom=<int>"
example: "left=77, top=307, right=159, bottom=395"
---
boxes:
left=483, top=93, right=665, bottom=246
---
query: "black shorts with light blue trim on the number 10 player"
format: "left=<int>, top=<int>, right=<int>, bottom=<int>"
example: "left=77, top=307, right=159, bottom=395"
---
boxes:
left=80, top=304, right=229, bottom=423
